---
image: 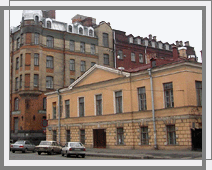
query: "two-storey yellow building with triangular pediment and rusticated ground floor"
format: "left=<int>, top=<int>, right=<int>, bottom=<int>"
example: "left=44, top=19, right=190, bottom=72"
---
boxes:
left=46, top=60, right=202, bottom=149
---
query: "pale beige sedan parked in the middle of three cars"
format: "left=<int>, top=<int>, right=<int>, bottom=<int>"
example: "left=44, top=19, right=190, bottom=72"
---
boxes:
left=35, top=141, right=62, bottom=155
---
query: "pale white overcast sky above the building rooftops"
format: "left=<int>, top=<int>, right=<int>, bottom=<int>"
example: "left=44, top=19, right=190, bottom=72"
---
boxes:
left=10, top=10, right=202, bottom=62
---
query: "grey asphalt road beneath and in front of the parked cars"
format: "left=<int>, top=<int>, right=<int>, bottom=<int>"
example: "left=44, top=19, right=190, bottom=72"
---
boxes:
left=9, top=151, right=126, bottom=160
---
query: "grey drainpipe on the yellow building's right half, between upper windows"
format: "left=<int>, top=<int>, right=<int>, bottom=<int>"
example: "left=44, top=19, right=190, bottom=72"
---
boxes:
left=148, top=68, right=158, bottom=149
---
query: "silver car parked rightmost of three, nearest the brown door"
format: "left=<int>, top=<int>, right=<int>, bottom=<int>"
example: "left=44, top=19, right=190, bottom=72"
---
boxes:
left=61, top=142, right=86, bottom=158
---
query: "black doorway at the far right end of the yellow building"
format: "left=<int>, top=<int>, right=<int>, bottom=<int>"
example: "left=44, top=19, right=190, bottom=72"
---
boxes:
left=191, top=129, right=202, bottom=150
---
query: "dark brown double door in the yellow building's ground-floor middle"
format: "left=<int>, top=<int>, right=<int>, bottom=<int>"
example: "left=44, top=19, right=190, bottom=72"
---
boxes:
left=93, top=129, right=106, bottom=148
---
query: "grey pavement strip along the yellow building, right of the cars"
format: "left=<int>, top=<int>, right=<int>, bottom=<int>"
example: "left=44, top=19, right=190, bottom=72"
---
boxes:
left=86, top=148, right=202, bottom=160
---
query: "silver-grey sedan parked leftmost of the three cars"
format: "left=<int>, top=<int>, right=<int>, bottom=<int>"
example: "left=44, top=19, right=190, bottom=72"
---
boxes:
left=10, top=140, right=35, bottom=153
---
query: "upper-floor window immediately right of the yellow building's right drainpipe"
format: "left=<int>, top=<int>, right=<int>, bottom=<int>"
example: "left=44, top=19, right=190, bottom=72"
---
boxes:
left=163, top=83, right=174, bottom=108
